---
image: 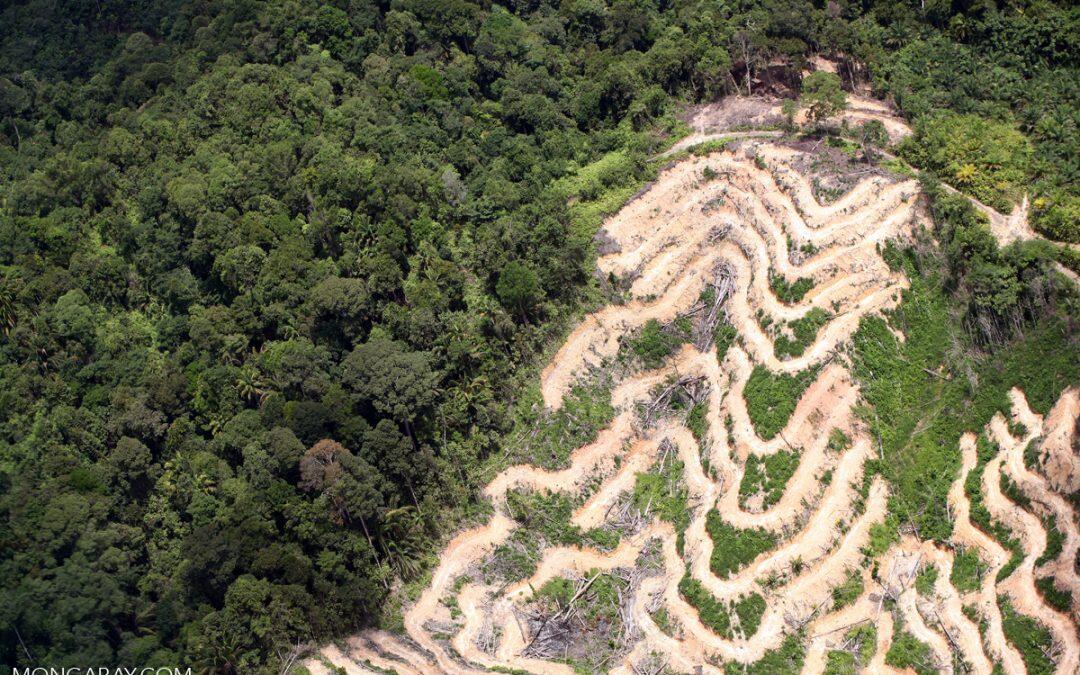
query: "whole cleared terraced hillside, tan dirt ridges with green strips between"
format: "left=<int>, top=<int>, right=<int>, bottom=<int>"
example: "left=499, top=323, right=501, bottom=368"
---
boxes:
left=307, top=113, right=1080, bottom=673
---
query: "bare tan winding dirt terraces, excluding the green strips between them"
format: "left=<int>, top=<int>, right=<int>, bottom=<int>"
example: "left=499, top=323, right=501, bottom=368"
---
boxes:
left=306, top=111, right=1080, bottom=674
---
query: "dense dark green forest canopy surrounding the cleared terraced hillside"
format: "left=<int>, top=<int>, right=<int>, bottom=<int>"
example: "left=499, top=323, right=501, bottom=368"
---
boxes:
left=0, top=0, right=1080, bottom=673
